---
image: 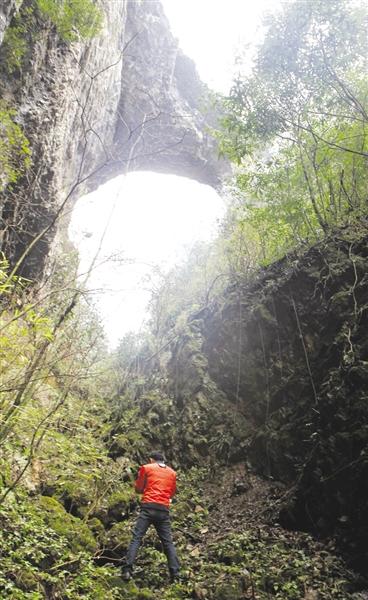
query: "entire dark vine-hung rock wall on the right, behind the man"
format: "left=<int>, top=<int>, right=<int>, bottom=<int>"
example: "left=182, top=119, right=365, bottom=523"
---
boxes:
left=137, top=221, right=368, bottom=573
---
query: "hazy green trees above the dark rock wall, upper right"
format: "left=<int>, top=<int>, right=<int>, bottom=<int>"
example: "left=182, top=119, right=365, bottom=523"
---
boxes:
left=221, top=0, right=368, bottom=262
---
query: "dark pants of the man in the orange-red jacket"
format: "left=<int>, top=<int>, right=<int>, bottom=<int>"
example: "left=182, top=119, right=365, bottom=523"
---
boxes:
left=125, top=507, right=180, bottom=575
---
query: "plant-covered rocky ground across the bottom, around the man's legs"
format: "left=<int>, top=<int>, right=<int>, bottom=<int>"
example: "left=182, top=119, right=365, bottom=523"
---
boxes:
left=0, top=438, right=368, bottom=600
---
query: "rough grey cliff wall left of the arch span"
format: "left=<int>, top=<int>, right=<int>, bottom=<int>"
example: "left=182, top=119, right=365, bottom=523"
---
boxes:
left=0, top=0, right=126, bottom=279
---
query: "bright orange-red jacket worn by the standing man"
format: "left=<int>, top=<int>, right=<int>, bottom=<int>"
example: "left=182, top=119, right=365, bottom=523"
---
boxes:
left=135, top=462, right=176, bottom=507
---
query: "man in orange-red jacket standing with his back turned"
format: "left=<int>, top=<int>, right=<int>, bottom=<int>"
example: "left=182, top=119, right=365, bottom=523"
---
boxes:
left=122, top=452, right=180, bottom=582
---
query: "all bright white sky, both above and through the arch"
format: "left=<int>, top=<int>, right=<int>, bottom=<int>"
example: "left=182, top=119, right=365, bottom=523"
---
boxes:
left=70, top=0, right=280, bottom=347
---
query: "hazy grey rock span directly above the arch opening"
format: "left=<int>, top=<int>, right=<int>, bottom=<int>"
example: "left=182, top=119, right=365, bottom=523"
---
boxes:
left=114, top=2, right=224, bottom=186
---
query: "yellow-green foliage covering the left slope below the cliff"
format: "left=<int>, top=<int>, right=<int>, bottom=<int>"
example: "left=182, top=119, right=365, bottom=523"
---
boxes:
left=0, top=257, right=136, bottom=600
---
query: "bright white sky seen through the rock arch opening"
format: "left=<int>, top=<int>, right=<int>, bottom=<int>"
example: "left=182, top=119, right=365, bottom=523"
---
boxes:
left=69, top=172, right=225, bottom=347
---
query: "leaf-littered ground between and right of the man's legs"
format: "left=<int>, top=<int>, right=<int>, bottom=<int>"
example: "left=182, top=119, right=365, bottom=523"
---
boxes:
left=112, top=465, right=368, bottom=600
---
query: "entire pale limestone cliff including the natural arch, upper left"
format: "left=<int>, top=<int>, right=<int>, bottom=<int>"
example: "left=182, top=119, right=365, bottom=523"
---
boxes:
left=0, top=0, right=227, bottom=278
